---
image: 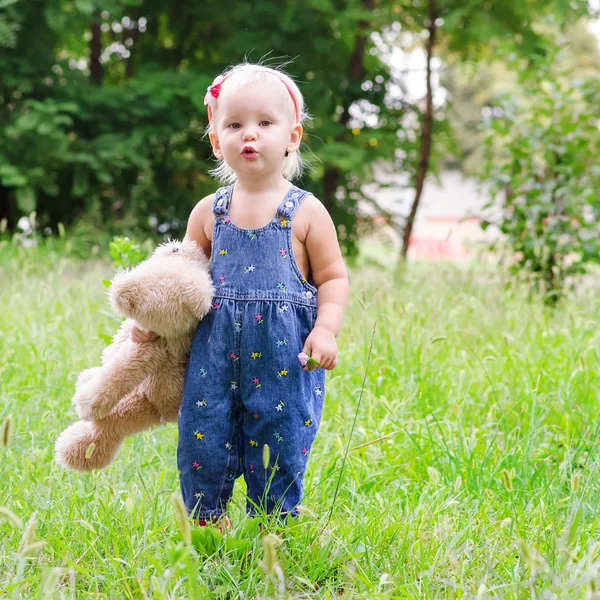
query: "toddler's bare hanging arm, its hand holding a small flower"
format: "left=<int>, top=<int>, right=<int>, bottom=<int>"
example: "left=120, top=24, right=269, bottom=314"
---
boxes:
left=304, top=198, right=349, bottom=370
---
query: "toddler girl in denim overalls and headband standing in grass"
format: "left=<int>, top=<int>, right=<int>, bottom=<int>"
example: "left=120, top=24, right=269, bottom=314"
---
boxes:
left=135, top=63, right=348, bottom=525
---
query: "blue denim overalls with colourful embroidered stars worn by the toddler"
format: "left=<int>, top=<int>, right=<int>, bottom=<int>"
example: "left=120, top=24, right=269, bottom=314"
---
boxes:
left=177, top=186, right=325, bottom=520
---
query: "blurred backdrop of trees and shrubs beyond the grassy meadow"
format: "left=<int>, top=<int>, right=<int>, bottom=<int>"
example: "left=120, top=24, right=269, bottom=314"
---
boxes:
left=0, top=0, right=600, bottom=290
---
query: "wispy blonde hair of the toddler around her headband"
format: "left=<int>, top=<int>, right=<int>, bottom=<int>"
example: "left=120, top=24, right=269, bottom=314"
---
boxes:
left=205, top=62, right=311, bottom=185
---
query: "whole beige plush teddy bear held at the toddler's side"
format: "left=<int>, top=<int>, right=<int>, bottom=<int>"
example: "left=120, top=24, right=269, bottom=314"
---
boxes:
left=55, top=239, right=214, bottom=471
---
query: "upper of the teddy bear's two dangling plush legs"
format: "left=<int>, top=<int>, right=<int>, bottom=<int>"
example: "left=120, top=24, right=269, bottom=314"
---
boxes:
left=73, top=342, right=166, bottom=421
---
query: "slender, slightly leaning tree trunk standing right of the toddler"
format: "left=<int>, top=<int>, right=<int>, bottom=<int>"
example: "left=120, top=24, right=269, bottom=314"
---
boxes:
left=400, top=0, right=437, bottom=261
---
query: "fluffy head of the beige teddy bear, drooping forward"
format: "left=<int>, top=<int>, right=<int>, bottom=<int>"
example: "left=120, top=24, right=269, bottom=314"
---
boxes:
left=109, top=238, right=214, bottom=338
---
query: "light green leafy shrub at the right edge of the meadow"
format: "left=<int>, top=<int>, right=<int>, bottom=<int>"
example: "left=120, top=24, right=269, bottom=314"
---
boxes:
left=481, top=52, right=600, bottom=303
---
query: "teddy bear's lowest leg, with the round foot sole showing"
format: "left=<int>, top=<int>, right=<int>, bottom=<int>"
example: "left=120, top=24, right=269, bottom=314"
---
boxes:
left=55, top=393, right=160, bottom=471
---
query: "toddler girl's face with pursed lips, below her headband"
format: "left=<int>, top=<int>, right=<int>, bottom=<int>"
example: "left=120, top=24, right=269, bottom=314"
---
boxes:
left=210, top=77, right=302, bottom=176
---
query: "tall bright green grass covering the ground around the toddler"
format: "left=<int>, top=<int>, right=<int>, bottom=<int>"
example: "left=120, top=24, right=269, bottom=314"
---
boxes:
left=0, top=240, right=600, bottom=599
